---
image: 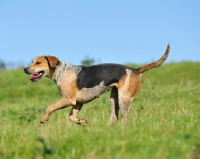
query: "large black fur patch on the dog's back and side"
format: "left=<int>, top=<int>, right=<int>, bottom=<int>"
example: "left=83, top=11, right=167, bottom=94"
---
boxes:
left=77, top=64, right=132, bottom=89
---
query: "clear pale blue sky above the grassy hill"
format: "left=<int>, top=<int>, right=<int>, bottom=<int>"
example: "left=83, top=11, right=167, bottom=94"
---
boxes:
left=0, top=0, right=200, bottom=65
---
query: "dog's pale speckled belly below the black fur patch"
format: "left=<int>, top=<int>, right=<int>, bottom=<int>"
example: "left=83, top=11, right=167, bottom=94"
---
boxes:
left=76, top=82, right=108, bottom=103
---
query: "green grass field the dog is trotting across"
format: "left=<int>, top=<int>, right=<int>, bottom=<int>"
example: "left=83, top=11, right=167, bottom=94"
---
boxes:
left=0, top=62, right=200, bottom=159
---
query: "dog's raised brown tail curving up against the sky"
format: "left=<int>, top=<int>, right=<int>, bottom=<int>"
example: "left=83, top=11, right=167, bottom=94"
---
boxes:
left=138, top=44, right=170, bottom=74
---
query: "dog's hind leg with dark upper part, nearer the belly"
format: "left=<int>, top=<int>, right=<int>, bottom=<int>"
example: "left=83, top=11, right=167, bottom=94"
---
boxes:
left=108, top=87, right=119, bottom=125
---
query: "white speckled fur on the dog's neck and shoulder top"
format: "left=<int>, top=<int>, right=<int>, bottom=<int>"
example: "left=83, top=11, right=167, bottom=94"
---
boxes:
left=52, top=61, right=82, bottom=85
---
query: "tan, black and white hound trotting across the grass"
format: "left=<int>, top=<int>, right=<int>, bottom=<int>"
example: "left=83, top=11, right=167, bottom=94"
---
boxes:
left=24, top=44, right=170, bottom=126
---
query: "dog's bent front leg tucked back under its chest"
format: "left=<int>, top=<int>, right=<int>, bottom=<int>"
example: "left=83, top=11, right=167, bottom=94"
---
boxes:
left=69, top=104, right=87, bottom=126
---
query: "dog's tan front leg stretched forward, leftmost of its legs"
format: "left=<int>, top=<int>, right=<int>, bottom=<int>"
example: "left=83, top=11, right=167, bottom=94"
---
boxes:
left=40, top=98, right=76, bottom=124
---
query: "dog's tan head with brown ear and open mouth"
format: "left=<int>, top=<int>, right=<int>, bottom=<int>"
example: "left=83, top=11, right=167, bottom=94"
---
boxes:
left=24, top=56, right=59, bottom=82
